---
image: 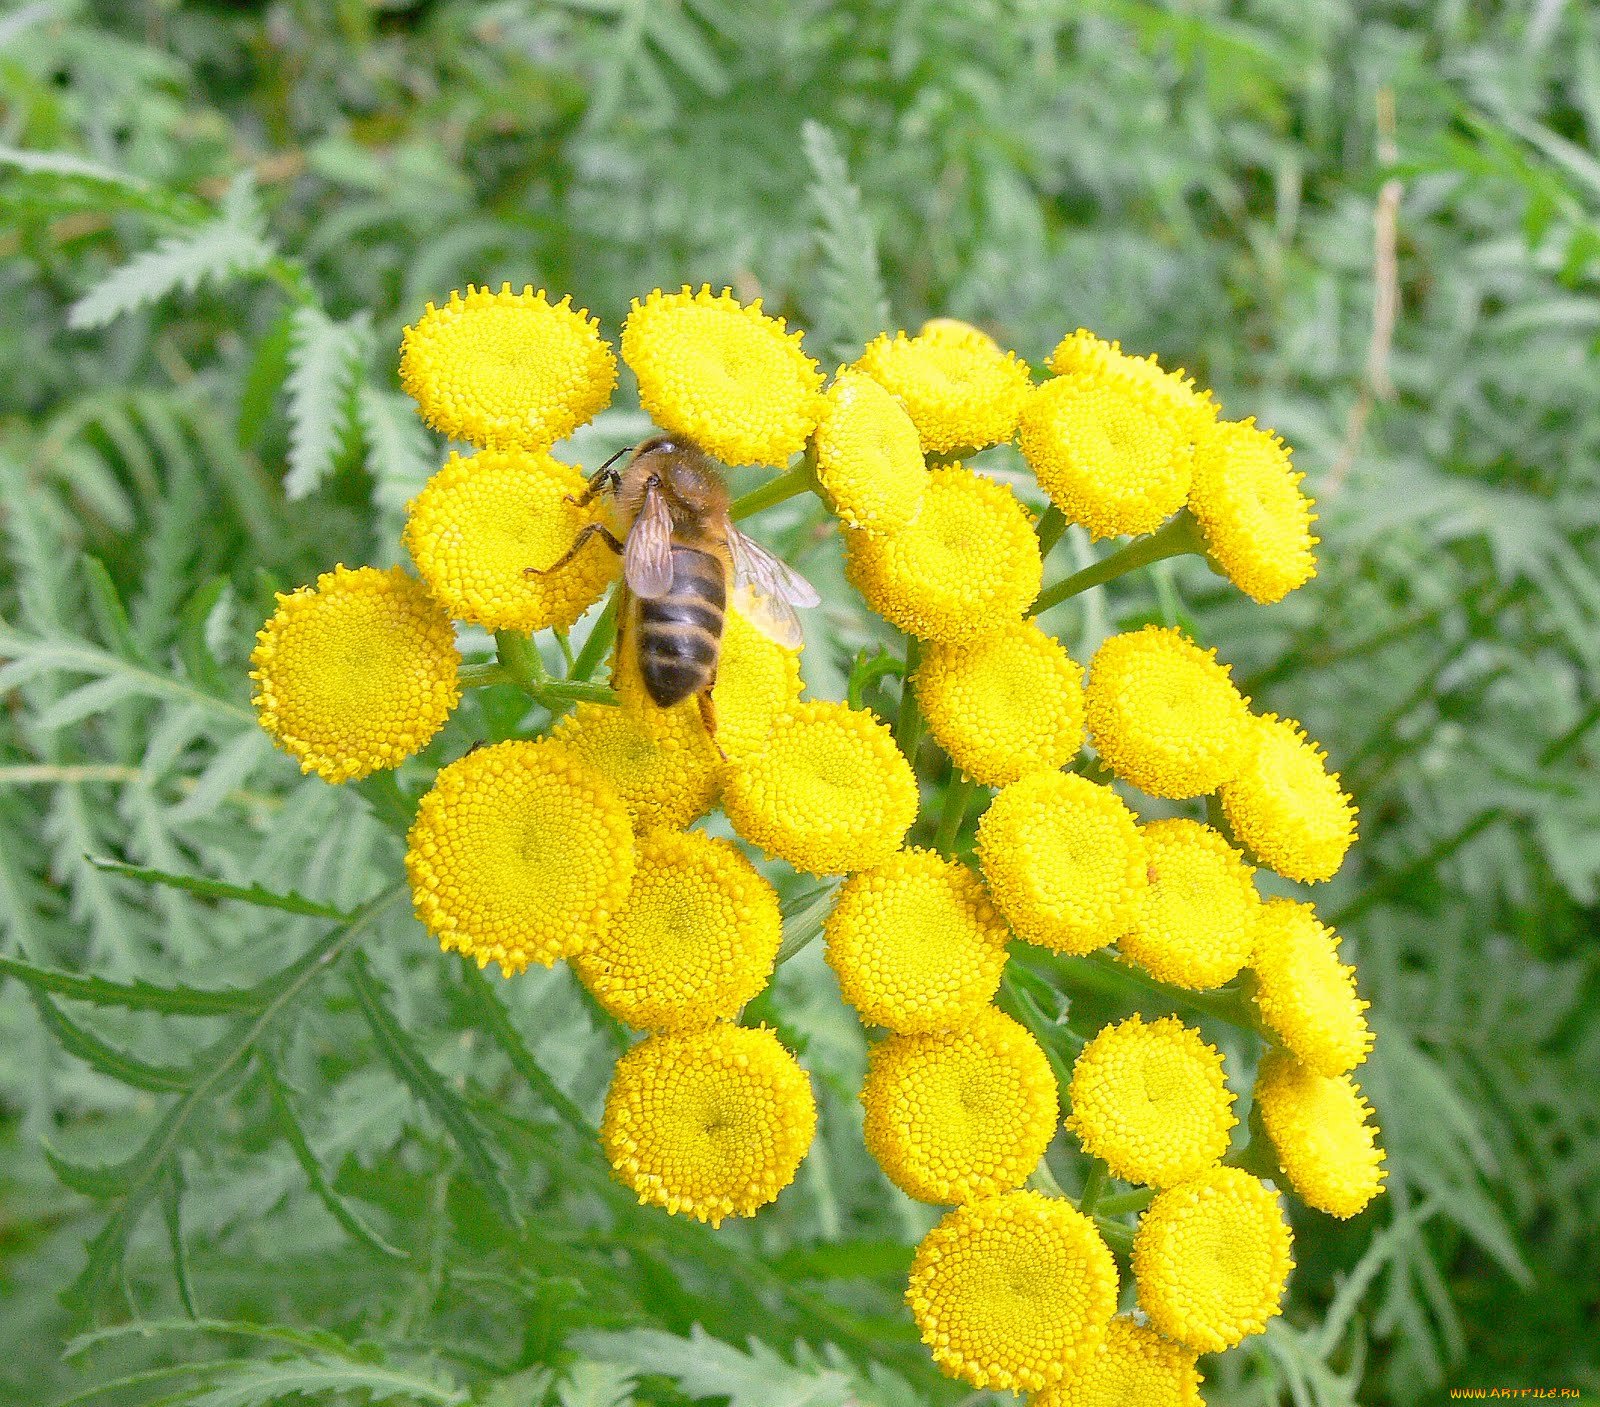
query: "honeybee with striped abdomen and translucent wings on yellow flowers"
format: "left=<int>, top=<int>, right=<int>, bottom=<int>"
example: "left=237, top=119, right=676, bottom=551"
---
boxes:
left=525, top=435, right=819, bottom=740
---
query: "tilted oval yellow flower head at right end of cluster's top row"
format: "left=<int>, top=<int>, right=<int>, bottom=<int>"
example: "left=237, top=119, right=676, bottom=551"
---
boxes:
left=1189, top=419, right=1318, bottom=605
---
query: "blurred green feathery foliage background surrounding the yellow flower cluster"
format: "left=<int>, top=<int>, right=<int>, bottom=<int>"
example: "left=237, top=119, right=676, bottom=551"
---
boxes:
left=0, top=0, right=1600, bottom=1407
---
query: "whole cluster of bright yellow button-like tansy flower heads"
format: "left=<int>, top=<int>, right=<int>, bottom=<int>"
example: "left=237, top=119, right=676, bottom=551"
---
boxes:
left=251, top=285, right=1382, bottom=1407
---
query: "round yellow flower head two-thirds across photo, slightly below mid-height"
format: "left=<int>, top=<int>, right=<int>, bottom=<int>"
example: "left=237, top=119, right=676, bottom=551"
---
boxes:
left=978, top=772, right=1147, bottom=954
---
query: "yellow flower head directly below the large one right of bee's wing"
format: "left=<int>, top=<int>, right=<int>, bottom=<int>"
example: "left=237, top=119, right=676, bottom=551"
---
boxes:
left=914, top=621, right=1083, bottom=786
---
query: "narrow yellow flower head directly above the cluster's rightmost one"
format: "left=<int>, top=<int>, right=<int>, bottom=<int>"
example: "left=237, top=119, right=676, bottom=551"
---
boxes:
left=1250, top=900, right=1373, bottom=1076
